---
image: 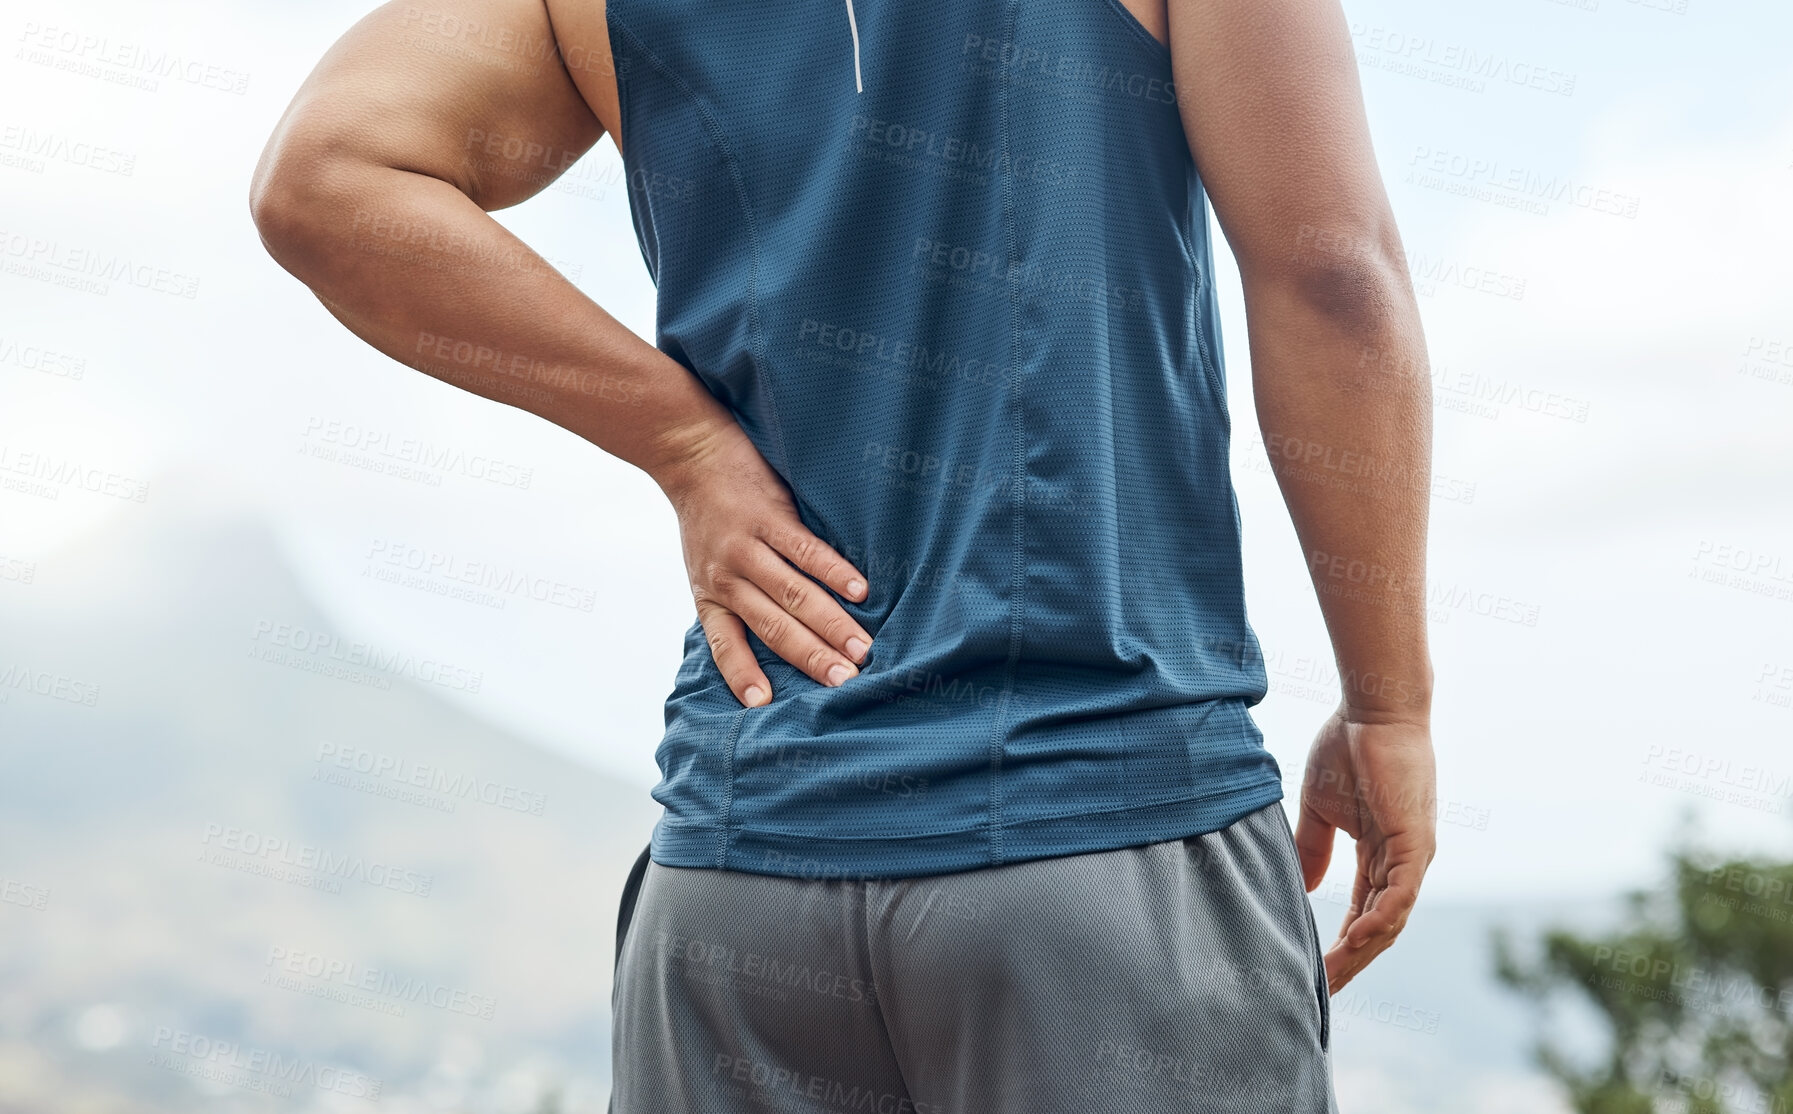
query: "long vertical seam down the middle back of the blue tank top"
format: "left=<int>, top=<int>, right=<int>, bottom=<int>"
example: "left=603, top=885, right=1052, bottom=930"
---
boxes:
left=984, top=0, right=1027, bottom=866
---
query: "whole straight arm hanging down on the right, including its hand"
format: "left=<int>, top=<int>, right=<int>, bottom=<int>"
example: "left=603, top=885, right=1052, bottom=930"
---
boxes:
left=1167, top=0, right=1436, bottom=992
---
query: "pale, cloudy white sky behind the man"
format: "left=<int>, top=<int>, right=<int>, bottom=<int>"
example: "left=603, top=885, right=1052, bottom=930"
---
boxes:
left=0, top=0, right=1793, bottom=897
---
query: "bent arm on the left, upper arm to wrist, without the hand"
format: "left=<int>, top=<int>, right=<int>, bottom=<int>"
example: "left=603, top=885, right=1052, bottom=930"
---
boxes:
left=251, top=0, right=728, bottom=475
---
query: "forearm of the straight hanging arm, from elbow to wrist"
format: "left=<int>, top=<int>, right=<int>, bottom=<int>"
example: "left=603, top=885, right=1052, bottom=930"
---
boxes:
left=1246, top=249, right=1433, bottom=721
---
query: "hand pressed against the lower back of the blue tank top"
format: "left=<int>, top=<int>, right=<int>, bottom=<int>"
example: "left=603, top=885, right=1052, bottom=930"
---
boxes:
left=656, top=422, right=871, bottom=707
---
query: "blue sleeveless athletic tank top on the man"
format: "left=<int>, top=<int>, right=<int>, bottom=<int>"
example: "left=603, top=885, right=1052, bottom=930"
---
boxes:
left=606, top=0, right=1282, bottom=879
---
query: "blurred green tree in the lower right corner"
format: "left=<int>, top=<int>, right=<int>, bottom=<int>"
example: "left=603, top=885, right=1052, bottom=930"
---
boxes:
left=1494, top=845, right=1793, bottom=1114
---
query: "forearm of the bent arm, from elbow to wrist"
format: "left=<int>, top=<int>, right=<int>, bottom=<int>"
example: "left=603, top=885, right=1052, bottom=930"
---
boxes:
left=256, top=165, right=733, bottom=486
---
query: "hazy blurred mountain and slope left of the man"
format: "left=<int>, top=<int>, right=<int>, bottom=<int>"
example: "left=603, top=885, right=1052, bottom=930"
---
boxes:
left=0, top=506, right=658, bottom=1114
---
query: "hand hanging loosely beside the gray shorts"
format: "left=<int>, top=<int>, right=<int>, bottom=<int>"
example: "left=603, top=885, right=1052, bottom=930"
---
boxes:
left=1295, top=710, right=1438, bottom=994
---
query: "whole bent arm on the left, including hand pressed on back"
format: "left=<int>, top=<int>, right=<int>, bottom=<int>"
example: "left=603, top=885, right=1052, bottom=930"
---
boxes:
left=249, top=0, right=871, bottom=705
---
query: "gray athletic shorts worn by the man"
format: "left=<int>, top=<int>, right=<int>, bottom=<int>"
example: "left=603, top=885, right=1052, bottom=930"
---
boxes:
left=611, top=804, right=1338, bottom=1114
